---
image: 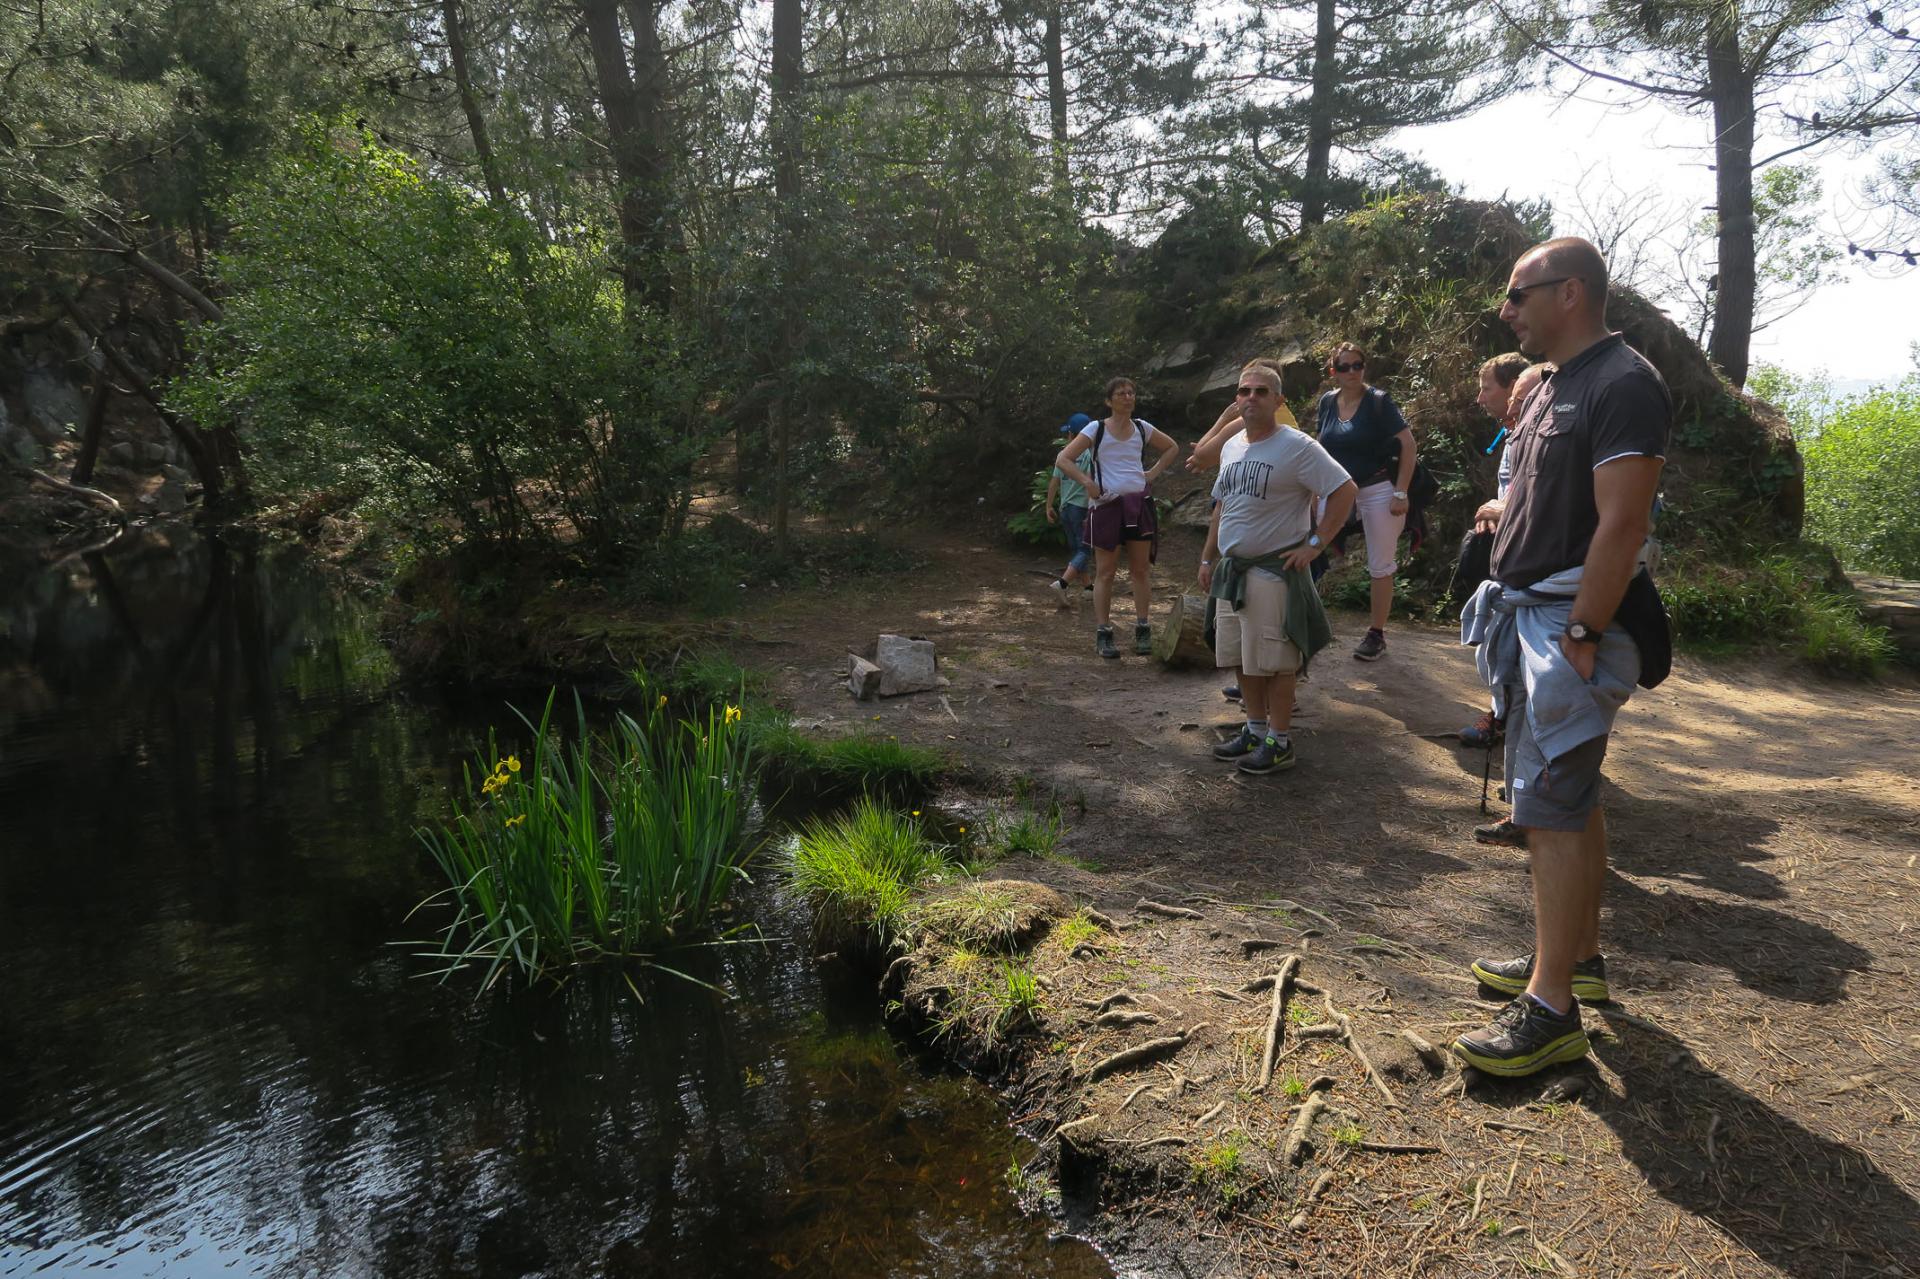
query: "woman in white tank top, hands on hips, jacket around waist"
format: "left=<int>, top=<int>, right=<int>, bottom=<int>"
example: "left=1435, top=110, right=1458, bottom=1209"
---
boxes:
left=1054, top=378, right=1181, bottom=657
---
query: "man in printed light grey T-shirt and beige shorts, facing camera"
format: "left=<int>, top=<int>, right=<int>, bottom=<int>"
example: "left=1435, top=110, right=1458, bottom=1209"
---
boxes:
left=1200, top=365, right=1356, bottom=774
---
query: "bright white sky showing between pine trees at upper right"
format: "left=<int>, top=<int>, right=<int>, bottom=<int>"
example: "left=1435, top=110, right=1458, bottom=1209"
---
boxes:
left=1394, top=90, right=1920, bottom=390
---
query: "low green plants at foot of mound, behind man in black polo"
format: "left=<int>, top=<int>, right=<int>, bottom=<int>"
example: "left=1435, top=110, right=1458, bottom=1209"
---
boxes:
left=1661, top=551, right=1893, bottom=674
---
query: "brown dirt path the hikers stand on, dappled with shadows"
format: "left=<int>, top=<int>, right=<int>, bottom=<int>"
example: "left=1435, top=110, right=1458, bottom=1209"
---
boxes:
left=739, top=534, right=1920, bottom=1275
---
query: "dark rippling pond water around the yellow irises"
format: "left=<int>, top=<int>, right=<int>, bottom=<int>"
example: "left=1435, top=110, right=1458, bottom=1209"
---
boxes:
left=0, top=532, right=1112, bottom=1279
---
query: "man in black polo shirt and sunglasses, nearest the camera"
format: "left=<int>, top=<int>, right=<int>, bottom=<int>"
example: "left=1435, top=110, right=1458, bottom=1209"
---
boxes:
left=1453, top=238, right=1672, bottom=1075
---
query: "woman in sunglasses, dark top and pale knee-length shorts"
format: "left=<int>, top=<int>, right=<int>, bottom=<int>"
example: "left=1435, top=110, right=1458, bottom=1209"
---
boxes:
left=1319, top=342, right=1415, bottom=663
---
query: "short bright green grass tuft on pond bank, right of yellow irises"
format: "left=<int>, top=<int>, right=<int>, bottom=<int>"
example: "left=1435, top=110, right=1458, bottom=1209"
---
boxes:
left=793, top=797, right=954, bottom=935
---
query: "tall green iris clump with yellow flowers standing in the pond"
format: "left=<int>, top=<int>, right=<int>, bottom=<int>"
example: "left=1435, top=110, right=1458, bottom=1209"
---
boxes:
left=419, top=695, right=755, bottom=983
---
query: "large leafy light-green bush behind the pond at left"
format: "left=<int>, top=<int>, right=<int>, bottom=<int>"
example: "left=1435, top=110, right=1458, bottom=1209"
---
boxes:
left=175, top=127, right=695, bottom=549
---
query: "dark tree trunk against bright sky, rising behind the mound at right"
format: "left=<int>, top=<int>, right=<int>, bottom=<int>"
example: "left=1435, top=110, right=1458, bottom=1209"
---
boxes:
left=1707, top=23, right=1757, bottom=386
